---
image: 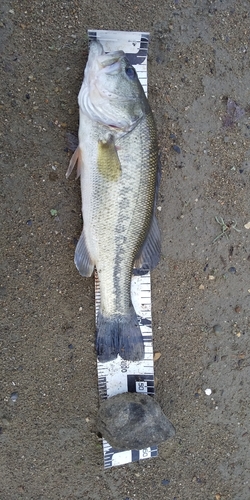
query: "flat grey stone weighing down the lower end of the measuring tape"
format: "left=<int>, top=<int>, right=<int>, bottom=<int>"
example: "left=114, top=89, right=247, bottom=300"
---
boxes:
left=97, top=392, right=175, bottom=450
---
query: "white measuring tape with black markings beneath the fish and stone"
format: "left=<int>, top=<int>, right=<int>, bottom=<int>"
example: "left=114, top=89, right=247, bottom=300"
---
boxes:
left=88, top=30, right=158, bottom=469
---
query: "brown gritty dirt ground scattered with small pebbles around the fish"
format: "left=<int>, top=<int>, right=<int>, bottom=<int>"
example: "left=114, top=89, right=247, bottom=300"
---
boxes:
left=0, top=0, right=250, bottom=500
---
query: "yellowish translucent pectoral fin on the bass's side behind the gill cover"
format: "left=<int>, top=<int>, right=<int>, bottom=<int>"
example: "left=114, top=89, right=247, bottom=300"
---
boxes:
left=97, top=136, right=122, bottom=181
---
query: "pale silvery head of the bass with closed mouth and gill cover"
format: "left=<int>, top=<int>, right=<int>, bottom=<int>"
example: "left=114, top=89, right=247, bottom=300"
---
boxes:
left=78, top=41, right=146, bottom=132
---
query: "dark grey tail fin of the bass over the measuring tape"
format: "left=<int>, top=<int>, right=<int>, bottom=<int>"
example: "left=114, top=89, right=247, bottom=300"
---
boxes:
left=96, top=307, right=144, bottom=363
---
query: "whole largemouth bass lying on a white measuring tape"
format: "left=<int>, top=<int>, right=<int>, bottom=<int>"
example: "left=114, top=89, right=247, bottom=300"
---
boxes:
left=66, top=41, right=160, bottom=362
